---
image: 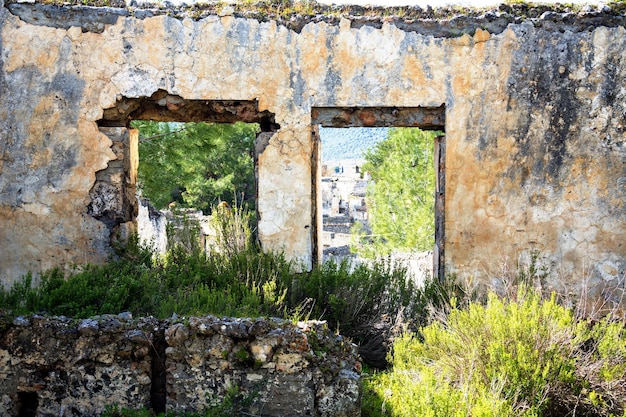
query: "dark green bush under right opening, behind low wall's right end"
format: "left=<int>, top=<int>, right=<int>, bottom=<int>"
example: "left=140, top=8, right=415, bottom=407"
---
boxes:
left=287, top=259, right=443, bottom=369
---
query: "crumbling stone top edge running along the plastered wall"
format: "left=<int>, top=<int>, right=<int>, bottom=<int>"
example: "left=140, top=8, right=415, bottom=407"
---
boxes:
left=6, top=0, right=626, bottom=38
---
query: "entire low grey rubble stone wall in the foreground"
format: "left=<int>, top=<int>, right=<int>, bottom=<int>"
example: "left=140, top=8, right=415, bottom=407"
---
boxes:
left=0, top=313, right=361, bottom=417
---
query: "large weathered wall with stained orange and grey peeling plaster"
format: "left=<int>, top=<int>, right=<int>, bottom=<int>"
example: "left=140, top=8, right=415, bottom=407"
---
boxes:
left=0, top=3, right=626, bottom=302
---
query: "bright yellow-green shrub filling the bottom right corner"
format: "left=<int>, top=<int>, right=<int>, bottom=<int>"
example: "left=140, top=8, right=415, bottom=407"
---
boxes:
left=364, top=289, right=626, bottom=417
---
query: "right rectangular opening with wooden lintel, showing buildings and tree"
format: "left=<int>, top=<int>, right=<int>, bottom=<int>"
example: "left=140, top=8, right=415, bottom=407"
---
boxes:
left=312, top=106, right=445, bottom=280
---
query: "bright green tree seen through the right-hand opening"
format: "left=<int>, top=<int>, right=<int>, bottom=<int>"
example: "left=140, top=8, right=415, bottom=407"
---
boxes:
left=353, top=128, right=438, bottom=256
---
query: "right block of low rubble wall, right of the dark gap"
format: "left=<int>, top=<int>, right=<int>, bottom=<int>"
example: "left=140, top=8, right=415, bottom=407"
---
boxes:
left=165, top=317, right=361, bottom=416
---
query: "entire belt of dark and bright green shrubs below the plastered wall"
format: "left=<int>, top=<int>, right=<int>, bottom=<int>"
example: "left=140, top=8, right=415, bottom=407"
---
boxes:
left=0, top=213, right=626, bottom=417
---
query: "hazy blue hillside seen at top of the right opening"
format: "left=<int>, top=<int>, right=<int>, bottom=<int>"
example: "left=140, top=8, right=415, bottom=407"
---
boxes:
left=320, top=127, right=389, bottom=161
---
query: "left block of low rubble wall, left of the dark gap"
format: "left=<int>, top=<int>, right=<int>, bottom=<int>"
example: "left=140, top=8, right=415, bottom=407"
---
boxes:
left=0, top=316, right=156, bottom=417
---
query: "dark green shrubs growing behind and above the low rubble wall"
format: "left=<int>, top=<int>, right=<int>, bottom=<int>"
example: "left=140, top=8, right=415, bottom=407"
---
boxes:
left=0, top=210, right=426, bottom=365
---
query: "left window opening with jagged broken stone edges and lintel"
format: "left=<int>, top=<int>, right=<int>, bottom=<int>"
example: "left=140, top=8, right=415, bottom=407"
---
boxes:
left=95, top=90, right=280, bottom=253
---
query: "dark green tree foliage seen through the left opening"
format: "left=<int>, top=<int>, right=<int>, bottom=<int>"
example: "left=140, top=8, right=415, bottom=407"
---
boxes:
left=131, top=120, right=258, bottom=213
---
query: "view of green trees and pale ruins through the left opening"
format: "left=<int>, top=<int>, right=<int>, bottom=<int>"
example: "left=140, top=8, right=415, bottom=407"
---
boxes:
left=130, top=120, right=260, bottom=252
